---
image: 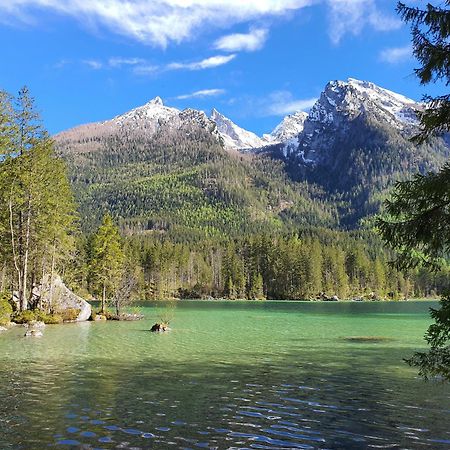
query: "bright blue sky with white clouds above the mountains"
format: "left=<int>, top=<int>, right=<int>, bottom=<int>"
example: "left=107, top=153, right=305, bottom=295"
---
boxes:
left=0, top=0, right=439, bottom=134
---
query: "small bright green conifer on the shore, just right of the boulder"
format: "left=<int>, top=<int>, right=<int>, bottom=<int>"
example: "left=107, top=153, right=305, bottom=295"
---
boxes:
left=90, top=214, right=124, bottom=313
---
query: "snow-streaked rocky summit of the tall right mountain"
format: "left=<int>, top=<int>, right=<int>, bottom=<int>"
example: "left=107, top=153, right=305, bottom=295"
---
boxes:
left=274, top=78, right=423, bottom=166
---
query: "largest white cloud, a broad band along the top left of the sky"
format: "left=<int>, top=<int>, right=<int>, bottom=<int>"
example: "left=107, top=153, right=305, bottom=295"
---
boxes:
left=0, top=0, right=317, bottom=47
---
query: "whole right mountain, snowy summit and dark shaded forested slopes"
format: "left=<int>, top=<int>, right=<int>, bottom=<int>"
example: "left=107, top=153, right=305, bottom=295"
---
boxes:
left=262, top=78, right=450, bottom=227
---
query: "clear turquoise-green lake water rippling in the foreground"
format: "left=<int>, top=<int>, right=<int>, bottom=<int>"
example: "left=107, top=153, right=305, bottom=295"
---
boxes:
left=0, top=302, right=450, bottom=449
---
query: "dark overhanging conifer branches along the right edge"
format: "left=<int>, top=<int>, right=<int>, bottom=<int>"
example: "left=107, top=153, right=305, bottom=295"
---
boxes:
left=377, top=0, right=450, bottom=380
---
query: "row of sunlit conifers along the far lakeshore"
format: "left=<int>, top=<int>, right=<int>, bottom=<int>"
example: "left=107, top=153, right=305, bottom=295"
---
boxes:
left=66, top=230, right=449, bottom=300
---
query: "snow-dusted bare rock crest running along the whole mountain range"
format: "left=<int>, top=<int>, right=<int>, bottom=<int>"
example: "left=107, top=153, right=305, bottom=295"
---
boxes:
left=57, top=78, right=423, bottom=158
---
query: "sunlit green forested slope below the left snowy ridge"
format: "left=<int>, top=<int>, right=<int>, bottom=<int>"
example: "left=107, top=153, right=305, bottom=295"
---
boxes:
left=58, top=125, right=336, bottom=236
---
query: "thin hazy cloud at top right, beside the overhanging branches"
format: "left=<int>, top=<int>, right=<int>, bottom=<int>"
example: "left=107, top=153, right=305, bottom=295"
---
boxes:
left=327, top=0, right=402, bottom=44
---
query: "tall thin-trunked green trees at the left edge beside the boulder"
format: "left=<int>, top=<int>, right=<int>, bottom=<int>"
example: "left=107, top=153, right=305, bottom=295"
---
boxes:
left=0, top=88, right=75, bottom=310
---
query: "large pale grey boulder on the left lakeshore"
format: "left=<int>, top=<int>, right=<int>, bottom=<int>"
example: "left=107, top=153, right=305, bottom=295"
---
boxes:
left=39, top=275, right=91, bottom=322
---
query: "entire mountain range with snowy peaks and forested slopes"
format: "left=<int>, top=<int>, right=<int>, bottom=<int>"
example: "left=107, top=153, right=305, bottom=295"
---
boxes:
left=55, top=78, right=449, bottom=235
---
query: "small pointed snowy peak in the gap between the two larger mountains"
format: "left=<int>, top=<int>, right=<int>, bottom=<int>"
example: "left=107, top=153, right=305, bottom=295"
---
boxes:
left=211, top=108, right=266, bottom=149
